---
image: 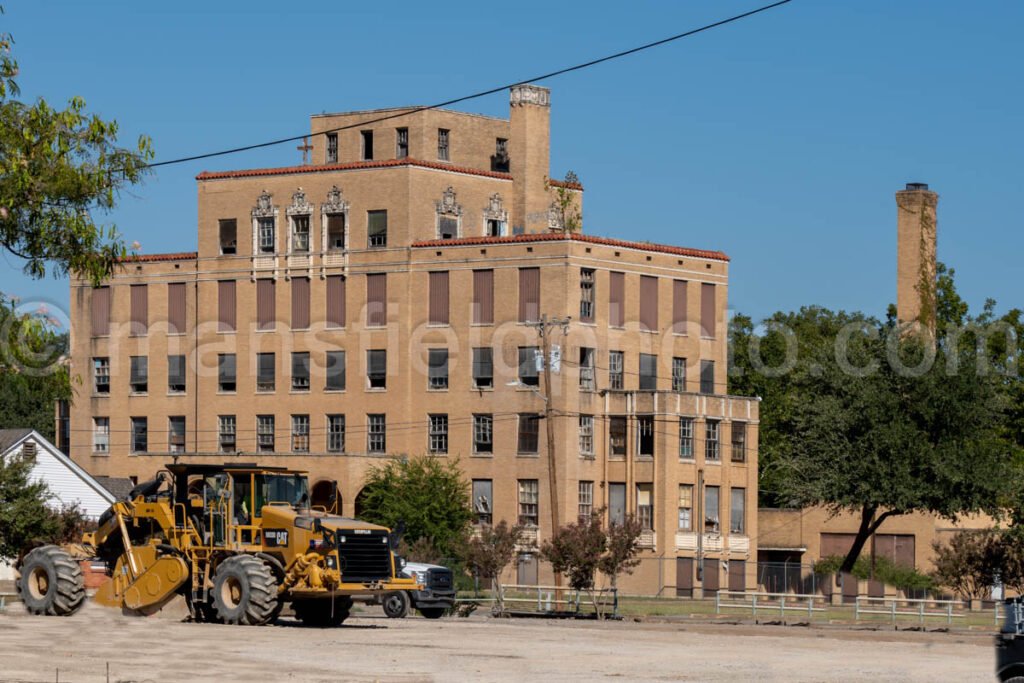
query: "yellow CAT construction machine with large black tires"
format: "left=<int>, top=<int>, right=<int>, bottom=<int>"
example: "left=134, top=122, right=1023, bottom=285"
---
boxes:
left=17, top=464, right=422, bottom=626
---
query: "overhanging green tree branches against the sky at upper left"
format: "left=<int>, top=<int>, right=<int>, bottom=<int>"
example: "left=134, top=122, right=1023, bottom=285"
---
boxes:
left=0, top=15, right=153, bottom=283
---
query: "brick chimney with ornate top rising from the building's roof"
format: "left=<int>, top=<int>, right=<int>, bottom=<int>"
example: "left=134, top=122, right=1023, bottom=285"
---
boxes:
left=509, top=85, right=551, bottom=232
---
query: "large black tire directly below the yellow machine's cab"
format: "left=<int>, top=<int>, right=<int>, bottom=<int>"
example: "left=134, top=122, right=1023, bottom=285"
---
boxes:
left=211, top=555, right=278, bottom=626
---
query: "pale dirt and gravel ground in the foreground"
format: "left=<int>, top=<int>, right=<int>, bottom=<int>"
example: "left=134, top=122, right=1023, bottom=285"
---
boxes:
left=0, top=604, right=994, bottom=683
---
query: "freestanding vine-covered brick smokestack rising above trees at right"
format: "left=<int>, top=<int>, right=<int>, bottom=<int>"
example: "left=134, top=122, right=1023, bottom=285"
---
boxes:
left=896, top=182, right=939, bottom=338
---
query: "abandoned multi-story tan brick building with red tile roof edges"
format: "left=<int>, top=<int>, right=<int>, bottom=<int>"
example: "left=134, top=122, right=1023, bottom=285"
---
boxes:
left=71, top=86, right=758, bottom=595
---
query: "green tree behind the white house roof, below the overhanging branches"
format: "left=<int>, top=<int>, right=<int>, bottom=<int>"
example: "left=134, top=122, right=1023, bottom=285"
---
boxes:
left=0, top=294, right=71, bottom=440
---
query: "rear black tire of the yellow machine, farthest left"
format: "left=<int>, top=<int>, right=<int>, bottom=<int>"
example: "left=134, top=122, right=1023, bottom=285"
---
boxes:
left=17, top=546, right=85, bottom=616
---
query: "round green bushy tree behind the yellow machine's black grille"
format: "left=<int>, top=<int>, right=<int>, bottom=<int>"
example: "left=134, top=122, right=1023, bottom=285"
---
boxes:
left=360, top=456, right=473, bottom=557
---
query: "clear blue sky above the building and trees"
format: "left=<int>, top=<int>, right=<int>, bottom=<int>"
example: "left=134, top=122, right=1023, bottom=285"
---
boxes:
left=0, top=0, right=1024, bottom=325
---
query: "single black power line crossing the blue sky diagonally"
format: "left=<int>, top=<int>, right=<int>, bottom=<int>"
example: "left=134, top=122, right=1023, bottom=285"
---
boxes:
left=146, top=0, right=792, bottom=168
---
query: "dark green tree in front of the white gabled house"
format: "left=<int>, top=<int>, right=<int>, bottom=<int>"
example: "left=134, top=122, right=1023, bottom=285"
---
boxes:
left=0, top=454, right=61, bottom=560
